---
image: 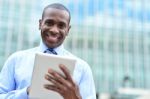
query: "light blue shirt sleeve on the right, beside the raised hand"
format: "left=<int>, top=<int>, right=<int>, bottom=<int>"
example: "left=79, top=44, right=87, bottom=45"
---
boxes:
left=79, top=64, right=96, bottom=99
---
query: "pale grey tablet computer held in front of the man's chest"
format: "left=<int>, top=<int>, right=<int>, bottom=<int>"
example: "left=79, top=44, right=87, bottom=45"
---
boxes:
left=29, top=53, right=76, bottom=99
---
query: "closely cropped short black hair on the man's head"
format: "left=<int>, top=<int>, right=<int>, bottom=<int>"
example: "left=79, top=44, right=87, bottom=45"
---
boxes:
left=42, top=3, right=71, bottom=23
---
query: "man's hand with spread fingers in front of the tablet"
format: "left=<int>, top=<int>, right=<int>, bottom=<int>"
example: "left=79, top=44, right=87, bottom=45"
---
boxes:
left=44, top=64, right=82, bottom=99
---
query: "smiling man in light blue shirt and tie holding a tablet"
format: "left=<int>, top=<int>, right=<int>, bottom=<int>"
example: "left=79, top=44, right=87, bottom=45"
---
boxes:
left=0, top=3, right=96, bottom=99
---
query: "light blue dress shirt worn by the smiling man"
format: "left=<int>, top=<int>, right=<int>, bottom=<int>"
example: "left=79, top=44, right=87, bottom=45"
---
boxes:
left=0, top=42, right=96, bottom=99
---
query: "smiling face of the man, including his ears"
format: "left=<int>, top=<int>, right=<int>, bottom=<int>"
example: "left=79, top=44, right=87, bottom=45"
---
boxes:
left=39, top=8, right=70, bottom=48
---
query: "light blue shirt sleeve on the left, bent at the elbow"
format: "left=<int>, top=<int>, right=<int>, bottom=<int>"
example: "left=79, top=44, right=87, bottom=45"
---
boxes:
left=0, top=56, right=28, bottom=99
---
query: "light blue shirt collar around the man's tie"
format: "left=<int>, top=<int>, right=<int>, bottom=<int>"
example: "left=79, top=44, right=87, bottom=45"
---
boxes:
left=39, top=40, right=64, bottom=54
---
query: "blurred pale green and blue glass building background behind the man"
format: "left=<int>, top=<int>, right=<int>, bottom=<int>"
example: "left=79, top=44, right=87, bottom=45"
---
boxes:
left=0, top=0, right=150, bottom=99
